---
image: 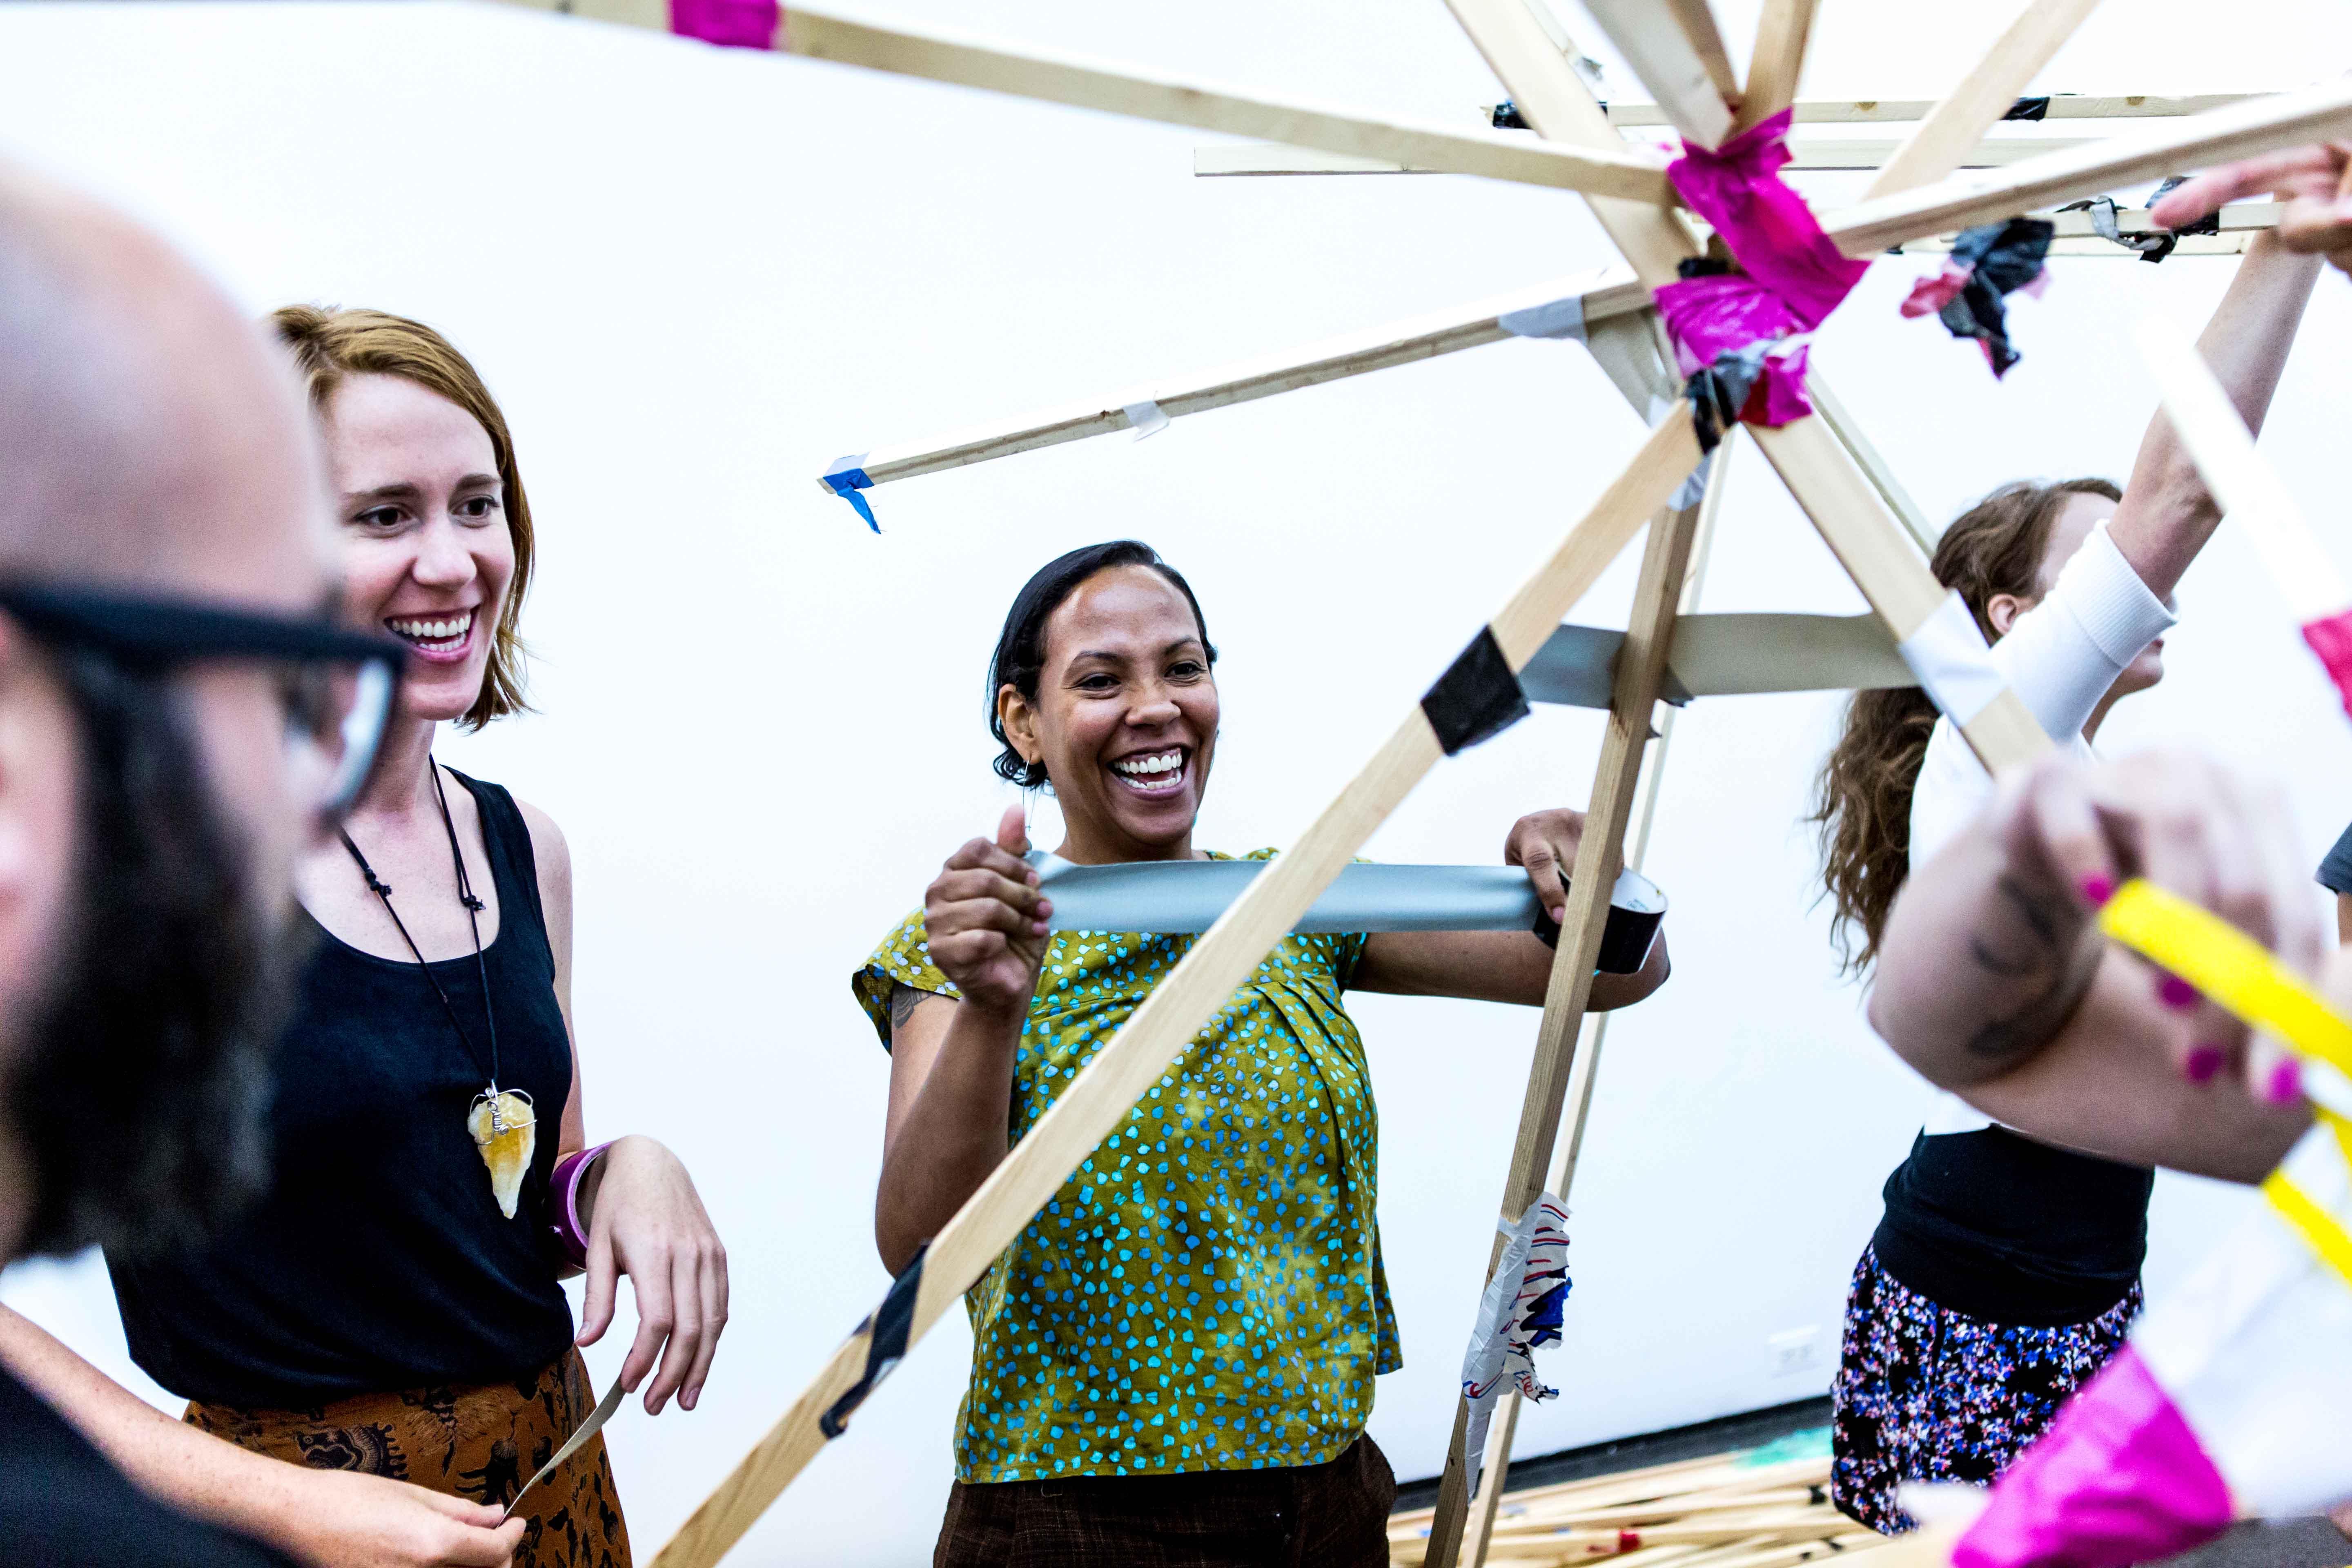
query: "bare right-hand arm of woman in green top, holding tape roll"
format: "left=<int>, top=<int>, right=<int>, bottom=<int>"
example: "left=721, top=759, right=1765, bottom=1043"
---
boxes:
left=1350, top=808, right=1672, bottom=1013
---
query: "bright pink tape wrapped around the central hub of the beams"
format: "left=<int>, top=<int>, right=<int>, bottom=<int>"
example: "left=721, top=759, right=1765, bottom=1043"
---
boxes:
left=1658, top=108, right=1870, bottom=425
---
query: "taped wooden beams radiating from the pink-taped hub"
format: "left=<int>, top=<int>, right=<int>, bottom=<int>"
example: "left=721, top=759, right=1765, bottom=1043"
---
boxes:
left=482, top=0, right=2352, bottom=1568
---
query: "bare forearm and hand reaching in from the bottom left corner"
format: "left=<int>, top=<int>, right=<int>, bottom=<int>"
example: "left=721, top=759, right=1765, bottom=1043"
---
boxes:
left=0, top=1307, right=524, bottom=1568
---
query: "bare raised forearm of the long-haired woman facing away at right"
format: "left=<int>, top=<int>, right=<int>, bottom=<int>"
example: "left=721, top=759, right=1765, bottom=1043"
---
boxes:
left=2107, top=235, right=2319, bottom=599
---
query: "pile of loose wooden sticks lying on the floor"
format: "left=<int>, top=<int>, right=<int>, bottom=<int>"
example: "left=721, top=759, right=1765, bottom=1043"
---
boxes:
left=1388, top=1432, right=1886, bottom=1568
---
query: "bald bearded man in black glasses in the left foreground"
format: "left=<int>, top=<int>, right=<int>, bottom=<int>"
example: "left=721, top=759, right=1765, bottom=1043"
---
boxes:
left=0, top=169, right=522, bottom=1568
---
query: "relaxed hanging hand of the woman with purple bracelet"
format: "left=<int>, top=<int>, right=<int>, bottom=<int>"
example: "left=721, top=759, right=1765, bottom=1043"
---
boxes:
left=579, top=1138, right=727, bottom=1415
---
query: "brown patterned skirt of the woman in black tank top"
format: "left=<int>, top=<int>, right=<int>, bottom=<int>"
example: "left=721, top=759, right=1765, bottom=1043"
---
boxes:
left=181, top=1350, right=630, bottom=1568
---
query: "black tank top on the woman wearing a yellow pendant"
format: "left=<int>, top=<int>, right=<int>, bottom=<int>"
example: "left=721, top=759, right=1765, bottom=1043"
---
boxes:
left=106, top=769, right=572, bottom=1410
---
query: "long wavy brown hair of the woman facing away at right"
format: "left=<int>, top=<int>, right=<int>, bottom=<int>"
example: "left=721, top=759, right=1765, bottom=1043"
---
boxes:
left=1806, top=479, right=2124, bottom=973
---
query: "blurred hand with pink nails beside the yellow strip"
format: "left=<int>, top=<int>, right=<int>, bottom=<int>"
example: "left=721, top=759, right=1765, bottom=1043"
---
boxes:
left=1955, top=752, right=2328, bottom=1105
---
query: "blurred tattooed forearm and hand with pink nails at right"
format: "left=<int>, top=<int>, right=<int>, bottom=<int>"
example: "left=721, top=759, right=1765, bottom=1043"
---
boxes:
left=1870, top=755, right=2326, bottom=1180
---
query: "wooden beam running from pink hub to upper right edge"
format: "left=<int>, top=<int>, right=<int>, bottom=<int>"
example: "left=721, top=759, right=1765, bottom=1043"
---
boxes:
left=1825, top=80, right=2352, bottom=256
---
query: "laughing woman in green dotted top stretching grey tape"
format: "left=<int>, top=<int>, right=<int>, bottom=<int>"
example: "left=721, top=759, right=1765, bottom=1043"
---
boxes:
left=856, top=541, right=1668, bottom=1568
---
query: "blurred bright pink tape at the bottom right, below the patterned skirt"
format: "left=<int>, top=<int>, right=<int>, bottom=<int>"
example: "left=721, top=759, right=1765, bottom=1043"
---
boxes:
left=1952, top=1345, right=2232, bottom=1568
